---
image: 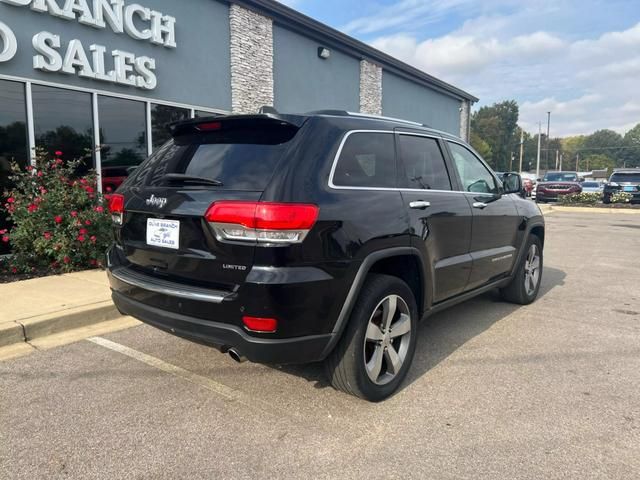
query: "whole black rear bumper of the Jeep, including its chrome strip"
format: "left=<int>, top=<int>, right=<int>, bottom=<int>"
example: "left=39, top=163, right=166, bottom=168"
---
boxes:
left=107, top=247, right=350, bottom=363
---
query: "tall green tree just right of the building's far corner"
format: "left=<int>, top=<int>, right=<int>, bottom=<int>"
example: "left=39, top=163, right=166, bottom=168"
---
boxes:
left=471, top=100, right=520, bottom=170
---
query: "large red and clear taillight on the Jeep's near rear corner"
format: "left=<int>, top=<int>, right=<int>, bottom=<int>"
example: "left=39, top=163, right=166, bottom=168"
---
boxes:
left=204, top=200, right=319, bottom=245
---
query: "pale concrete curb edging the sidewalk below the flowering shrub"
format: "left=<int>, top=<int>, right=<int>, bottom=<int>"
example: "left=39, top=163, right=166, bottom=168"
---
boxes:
left=0, top=300, right=121, bottom=347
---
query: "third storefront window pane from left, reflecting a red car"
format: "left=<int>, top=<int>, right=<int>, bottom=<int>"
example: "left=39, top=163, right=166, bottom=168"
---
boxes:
left=98, top=96, right=147, bottom=193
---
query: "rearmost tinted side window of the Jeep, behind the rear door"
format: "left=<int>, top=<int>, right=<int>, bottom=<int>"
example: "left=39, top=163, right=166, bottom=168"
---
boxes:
left=333, top=132, right=396, bottom=187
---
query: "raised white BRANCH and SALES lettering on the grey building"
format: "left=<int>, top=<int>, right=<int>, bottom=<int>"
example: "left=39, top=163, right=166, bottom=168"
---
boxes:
left=0, top=0, right=177, bottom=90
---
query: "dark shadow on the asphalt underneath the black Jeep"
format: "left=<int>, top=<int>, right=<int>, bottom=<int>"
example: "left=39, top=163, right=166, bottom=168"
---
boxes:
left=273, top=266, right=566, bottom=390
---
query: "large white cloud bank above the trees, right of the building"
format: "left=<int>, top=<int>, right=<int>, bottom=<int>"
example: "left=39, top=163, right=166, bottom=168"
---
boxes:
left=364, top=11, right=640, bottom=135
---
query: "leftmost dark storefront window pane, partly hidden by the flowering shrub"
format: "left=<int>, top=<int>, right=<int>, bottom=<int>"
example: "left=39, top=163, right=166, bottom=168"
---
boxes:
left=0, top=80, right=28, bottom=255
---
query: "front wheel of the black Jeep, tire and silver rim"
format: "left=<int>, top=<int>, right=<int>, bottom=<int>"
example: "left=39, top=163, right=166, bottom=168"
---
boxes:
left=500, top=235, right=543, bottom=305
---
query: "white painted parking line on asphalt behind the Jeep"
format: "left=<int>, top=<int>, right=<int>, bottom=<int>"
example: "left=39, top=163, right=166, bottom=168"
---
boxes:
left=87, top=337, right=291, bottom=420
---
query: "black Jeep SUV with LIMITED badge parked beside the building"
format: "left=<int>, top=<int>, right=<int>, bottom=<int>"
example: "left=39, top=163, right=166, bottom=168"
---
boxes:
left=108, top=111, right=544, bottom=401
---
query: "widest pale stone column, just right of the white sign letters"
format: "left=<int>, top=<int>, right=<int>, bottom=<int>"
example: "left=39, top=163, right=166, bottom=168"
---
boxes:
left=229, top=4, right=273, bottom=113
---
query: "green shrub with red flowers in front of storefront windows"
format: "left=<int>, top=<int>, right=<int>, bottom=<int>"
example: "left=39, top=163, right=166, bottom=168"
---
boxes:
left=0, top=151, right=112, bottom=273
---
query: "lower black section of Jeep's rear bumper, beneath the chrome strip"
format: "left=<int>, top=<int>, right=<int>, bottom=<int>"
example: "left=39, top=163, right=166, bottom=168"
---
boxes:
left=112, top=291, right=333, bottom=364
